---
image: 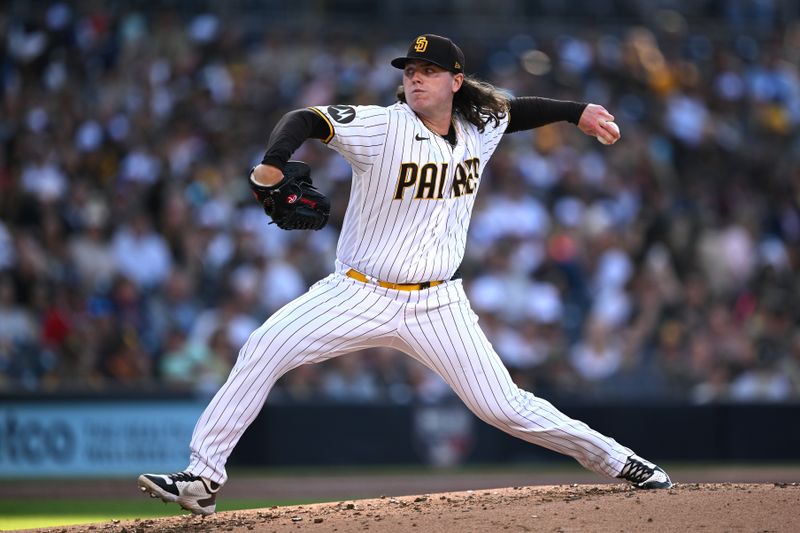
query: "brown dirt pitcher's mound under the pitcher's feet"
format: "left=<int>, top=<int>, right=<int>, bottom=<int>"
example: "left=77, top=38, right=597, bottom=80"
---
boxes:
left=36, top=483, right=800, bottom=533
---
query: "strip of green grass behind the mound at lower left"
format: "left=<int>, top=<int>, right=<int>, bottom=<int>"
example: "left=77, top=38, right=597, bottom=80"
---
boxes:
left=0, top=499, right=311, bottom=531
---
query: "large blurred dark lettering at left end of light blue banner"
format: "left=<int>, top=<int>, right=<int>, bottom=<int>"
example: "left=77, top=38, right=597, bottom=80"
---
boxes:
left=0, top=414, right=75, bottom=463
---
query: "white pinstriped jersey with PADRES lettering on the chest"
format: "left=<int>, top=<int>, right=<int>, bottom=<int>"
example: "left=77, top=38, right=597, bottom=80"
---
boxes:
left=311, top=102, right=508, bottom=283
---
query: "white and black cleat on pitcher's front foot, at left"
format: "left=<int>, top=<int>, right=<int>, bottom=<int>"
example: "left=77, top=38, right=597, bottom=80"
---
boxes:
left=137, top=472, right=220, bottom=515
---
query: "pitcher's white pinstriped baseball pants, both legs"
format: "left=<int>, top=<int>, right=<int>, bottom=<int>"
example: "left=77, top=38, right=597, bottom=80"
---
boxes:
left=187, top=268, right=633, bottom=484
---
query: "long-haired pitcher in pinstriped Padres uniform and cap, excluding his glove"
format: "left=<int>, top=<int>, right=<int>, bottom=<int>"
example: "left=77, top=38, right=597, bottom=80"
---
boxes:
left=138, top=34, right=672, bottom=514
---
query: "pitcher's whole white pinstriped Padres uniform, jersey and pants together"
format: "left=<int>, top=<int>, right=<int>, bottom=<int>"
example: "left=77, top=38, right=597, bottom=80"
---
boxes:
left=188, top=102, right=633, bottom=483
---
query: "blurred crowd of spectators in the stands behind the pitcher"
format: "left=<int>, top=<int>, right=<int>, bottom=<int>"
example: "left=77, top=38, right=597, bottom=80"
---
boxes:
left=0, top=2, right=800, bottom=403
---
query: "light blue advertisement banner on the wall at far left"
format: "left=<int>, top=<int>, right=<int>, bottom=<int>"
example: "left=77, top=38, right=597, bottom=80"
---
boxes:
left=0, top=402, right=205, bottom=478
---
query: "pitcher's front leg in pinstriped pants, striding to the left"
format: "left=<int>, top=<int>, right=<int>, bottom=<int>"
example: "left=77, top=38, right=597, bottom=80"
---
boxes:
left=187, top=276, right=399, bottom=484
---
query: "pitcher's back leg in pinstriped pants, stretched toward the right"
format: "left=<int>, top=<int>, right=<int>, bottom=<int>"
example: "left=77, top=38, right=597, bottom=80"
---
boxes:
left=403, top=285, right=633, bottom=477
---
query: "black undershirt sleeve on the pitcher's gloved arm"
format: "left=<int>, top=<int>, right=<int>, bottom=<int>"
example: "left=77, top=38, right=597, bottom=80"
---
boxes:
left=261, top=109, right=333, bottom=170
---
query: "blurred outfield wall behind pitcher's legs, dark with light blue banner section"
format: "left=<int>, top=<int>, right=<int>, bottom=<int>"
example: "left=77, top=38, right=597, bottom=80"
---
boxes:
left=0, top=398, right=800, bottom=478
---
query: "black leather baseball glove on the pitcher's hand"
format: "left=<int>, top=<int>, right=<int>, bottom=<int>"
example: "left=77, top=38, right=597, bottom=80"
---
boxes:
left=250, top=161, right=331, bottom=230
